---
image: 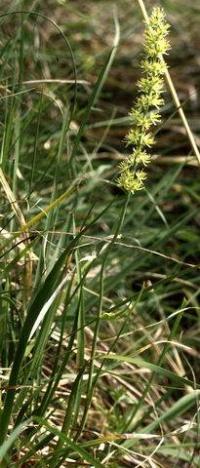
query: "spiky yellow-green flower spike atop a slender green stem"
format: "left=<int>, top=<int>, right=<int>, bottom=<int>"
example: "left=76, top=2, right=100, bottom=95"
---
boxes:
left=118, top=7, right=170, bottom=193
